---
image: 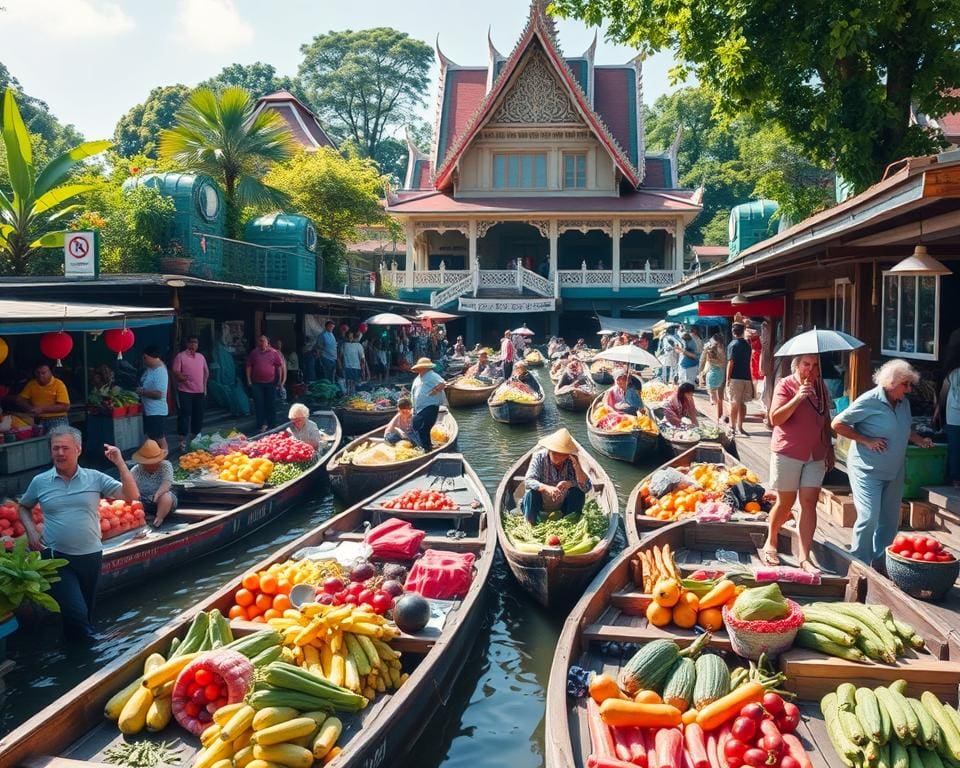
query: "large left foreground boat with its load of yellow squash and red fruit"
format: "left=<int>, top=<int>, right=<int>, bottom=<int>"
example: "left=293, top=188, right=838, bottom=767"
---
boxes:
left=0, top=454, right=496, bottom=768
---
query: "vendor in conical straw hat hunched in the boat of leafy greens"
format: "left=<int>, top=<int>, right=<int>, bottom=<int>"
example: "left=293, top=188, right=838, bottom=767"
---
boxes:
left=521, top=429, right=591, bottom=525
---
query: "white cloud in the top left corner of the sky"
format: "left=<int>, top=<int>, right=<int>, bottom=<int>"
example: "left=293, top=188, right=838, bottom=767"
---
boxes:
left=2, top=0, right=135, bottom=40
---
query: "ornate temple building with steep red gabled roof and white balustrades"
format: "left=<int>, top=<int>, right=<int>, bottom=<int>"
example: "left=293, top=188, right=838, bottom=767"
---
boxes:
left=382, top=0, right=702, bottom=340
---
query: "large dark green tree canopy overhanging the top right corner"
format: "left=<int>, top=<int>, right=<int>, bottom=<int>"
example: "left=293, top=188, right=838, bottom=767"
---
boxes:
left=552, top=0, right=960, bottom=189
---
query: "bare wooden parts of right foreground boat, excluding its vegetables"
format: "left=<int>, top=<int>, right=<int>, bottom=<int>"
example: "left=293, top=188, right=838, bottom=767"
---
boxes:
left=545, top=520, right=960, bottom=768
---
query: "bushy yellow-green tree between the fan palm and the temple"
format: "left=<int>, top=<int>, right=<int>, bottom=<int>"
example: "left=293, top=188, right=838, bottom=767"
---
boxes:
left=264, top=148, right=388, bottom=285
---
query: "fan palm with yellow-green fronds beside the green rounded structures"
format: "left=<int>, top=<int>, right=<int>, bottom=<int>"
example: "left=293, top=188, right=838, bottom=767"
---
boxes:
left=160, top=88, right=297, bottom=237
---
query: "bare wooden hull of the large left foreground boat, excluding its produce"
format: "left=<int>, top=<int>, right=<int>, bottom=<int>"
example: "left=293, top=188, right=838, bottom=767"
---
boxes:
left=0, top=454, right=496, bottom=768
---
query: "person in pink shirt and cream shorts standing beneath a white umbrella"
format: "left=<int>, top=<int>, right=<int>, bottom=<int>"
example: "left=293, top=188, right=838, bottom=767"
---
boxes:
left=762, top=355, right=834, bottom=570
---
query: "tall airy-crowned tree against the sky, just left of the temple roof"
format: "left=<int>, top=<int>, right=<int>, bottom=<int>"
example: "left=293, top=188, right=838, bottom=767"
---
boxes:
left=299, top=27, right=433, bottom=158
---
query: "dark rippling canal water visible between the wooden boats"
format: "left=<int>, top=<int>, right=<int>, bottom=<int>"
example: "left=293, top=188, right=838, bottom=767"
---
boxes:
left=0, top=369, right=664, bottom=768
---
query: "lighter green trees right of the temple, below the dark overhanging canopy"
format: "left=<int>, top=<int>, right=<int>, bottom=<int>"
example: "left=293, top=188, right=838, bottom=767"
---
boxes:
left=645, top=86, right=833, bottom=245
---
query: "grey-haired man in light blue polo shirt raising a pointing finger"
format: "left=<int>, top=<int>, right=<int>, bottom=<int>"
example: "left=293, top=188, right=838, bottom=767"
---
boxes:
left=18, top=426, right=140, bottom=640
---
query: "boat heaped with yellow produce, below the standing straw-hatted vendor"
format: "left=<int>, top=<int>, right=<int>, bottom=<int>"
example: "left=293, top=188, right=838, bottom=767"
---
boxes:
left=327, top=408, right=459, bottom=503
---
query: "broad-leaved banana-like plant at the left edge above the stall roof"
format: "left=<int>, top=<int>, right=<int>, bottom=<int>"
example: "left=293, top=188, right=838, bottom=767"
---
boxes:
left=0, top=88, right=112, bottom=275
